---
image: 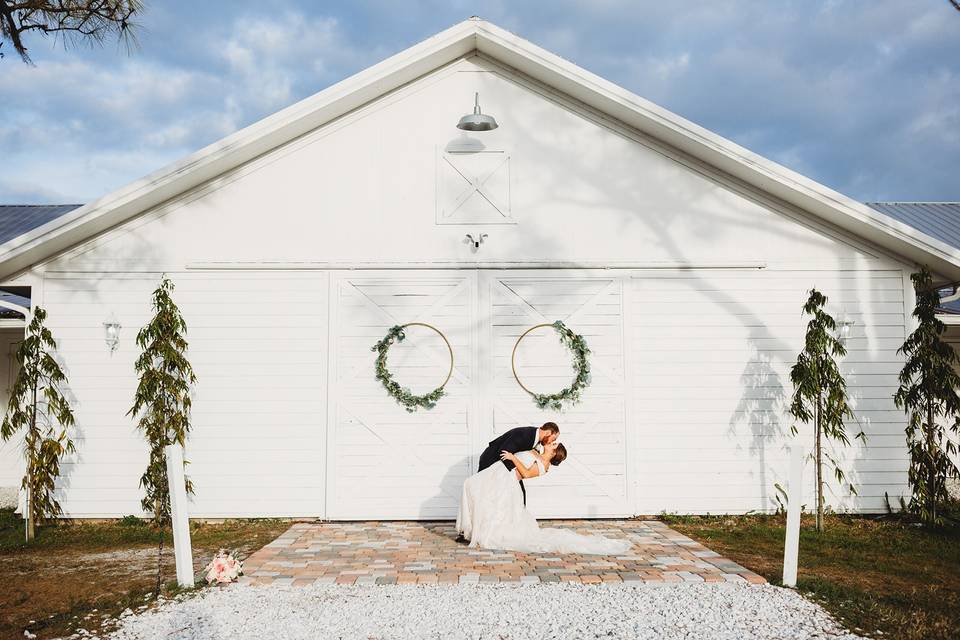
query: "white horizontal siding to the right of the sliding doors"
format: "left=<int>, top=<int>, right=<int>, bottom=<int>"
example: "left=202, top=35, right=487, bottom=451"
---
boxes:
left=631, top=268, right=908, bottom=513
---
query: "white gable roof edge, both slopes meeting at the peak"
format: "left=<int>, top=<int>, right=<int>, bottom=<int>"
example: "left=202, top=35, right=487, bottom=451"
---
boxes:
left=0, top=18, right=960, bottom=280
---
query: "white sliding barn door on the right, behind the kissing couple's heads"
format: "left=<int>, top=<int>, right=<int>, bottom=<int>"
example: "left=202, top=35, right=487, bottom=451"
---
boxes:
left=478, top=269, right=632, bottom=517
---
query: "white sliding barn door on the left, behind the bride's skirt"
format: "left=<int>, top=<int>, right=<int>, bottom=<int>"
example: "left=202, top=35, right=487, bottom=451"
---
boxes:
left=327, top=271, right=476, bottom=519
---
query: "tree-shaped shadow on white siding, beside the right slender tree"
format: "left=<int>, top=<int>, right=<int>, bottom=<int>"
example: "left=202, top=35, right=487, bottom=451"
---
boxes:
left=728, top=332, right=786, bottom=510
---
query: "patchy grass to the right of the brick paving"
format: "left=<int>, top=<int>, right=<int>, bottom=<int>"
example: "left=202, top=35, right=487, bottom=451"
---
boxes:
left=663, top=515, right=960, bottom=640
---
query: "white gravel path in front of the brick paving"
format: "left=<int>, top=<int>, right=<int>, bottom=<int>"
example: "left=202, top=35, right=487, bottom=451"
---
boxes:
left=94, top=584, right=858, bottom=640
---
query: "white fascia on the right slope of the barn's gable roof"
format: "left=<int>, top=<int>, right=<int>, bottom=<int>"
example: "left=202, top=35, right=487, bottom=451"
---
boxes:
left=477, top=22, right=960, bottom=277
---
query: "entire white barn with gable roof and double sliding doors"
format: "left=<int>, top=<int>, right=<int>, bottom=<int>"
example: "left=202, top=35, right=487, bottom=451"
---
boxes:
left=0, top=19, right=960, bottom=520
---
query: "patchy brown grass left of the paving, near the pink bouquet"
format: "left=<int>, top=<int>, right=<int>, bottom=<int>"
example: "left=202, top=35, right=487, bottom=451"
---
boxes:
left=0, top=510, right=290, bottom=638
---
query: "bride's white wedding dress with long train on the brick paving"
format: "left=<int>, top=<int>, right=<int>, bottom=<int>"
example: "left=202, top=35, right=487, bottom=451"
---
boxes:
left=457, top=451, right=633, bottom=555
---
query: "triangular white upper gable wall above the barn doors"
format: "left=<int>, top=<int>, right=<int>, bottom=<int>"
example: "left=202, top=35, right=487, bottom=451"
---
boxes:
left=48, top=57, right=874, bottom=270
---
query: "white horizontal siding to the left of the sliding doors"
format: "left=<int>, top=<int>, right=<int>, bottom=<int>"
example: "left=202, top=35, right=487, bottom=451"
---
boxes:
left=43, top=273, right=327, bottom=517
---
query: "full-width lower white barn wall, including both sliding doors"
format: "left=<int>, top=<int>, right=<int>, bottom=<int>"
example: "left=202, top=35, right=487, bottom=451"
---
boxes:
left=22, top=266, right=908, bottom=519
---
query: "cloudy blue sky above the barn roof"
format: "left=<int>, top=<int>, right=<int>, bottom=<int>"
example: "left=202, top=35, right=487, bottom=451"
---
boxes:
left=0, top=0, right=960, bottom=203
